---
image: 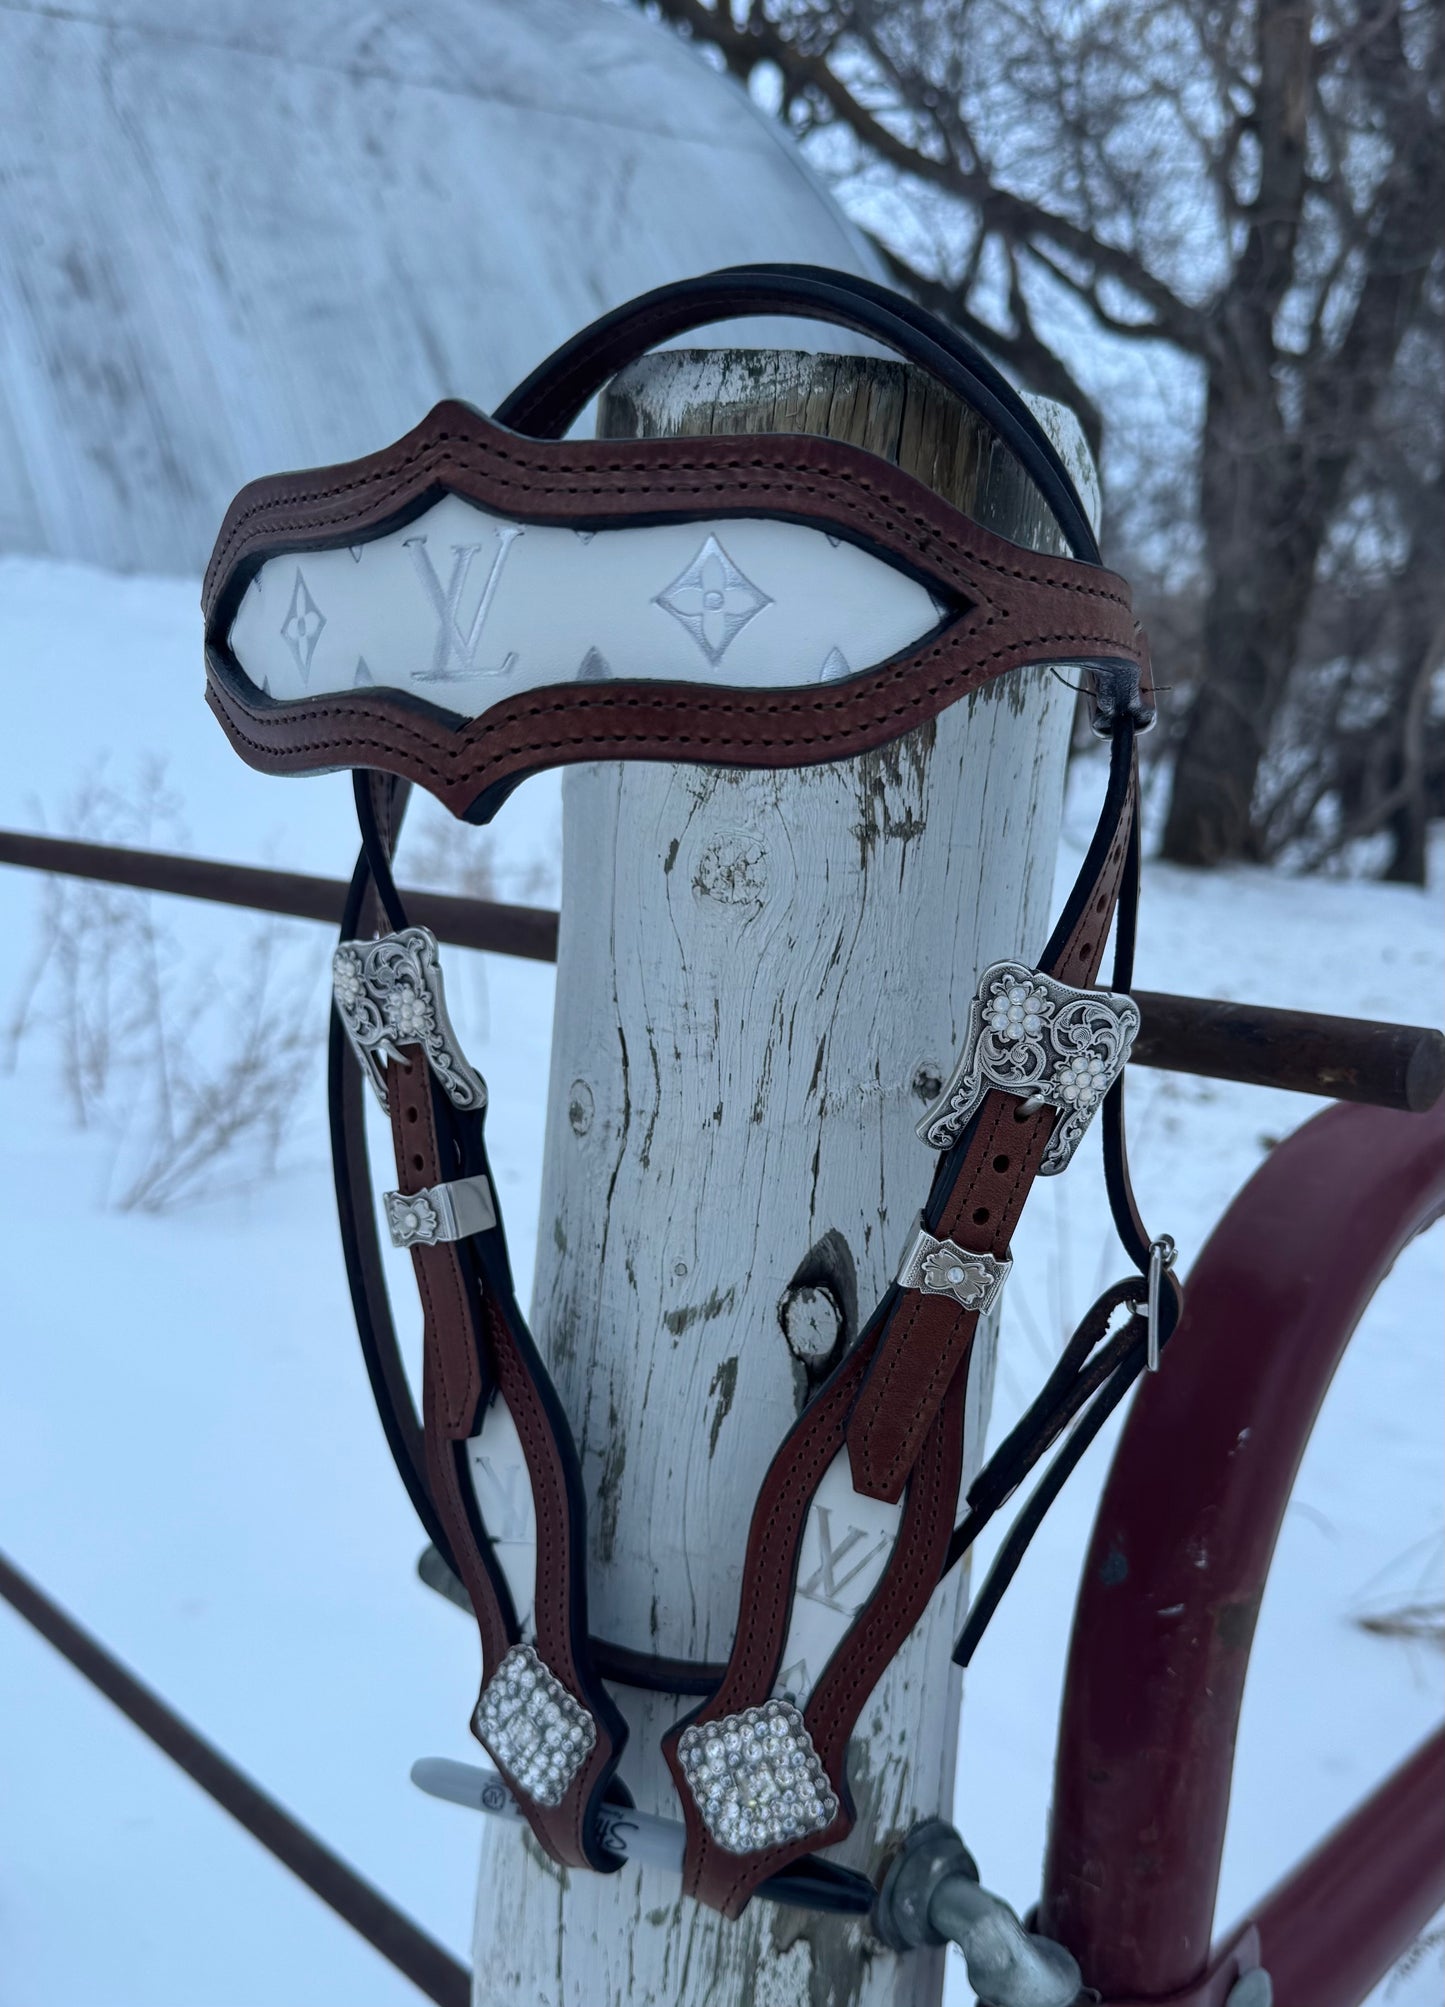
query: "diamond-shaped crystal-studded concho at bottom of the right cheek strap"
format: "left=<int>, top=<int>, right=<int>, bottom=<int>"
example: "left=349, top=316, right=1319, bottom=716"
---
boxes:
left=678, top=1700, right=839, bottom=1854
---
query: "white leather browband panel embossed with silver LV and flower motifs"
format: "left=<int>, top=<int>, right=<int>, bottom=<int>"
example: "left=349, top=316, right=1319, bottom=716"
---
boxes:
left=229, top=496, right=945, bottom=719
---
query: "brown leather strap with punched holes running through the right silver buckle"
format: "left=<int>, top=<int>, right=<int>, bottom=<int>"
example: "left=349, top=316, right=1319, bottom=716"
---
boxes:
left=847, top=779, right=1138, bottom=1499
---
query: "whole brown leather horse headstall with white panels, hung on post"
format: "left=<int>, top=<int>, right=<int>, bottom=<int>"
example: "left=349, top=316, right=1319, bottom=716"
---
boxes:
left=205, top=267, right=1178, bottom=1915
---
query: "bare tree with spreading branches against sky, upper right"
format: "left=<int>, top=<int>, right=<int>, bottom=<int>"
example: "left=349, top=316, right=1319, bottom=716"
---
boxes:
left=646, top=0, right=1445, bottom=875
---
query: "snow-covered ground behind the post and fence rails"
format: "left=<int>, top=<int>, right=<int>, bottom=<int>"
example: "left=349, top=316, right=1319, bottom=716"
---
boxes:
left=0, top=560, right=1445, bottom=2007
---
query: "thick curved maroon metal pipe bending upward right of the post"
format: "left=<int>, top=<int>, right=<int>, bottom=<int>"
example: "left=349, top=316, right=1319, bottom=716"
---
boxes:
left=1040, top=1106, right=1445, bottom=1999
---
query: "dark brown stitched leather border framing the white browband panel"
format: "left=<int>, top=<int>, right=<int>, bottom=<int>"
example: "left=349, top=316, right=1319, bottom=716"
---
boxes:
left=203, top=401, right=1152, bottom=815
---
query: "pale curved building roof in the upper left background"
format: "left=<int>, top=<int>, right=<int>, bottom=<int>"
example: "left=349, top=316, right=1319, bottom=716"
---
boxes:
left=0, top=0, right=867, bottom=572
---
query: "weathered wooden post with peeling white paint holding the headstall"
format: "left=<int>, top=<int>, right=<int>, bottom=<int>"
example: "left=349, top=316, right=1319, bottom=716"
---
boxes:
left=476, top=349, right=1094, bottom=2007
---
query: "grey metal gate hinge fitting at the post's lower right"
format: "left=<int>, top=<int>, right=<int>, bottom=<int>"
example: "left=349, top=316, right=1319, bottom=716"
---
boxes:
left=873, top=1818, right=1082, bottom=2007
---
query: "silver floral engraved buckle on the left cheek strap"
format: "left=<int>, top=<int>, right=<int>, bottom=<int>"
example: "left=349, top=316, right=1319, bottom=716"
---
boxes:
left=331, top=927, right=486, bottom=1108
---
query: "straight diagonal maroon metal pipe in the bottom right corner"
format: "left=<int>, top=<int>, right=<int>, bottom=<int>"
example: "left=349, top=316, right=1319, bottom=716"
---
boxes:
left=1254, top=1728, right=1445, bottom=2007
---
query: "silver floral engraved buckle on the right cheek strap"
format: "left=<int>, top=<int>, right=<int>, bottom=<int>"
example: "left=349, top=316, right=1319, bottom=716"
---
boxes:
left=917, top=961, right=1140, bottom=1178
